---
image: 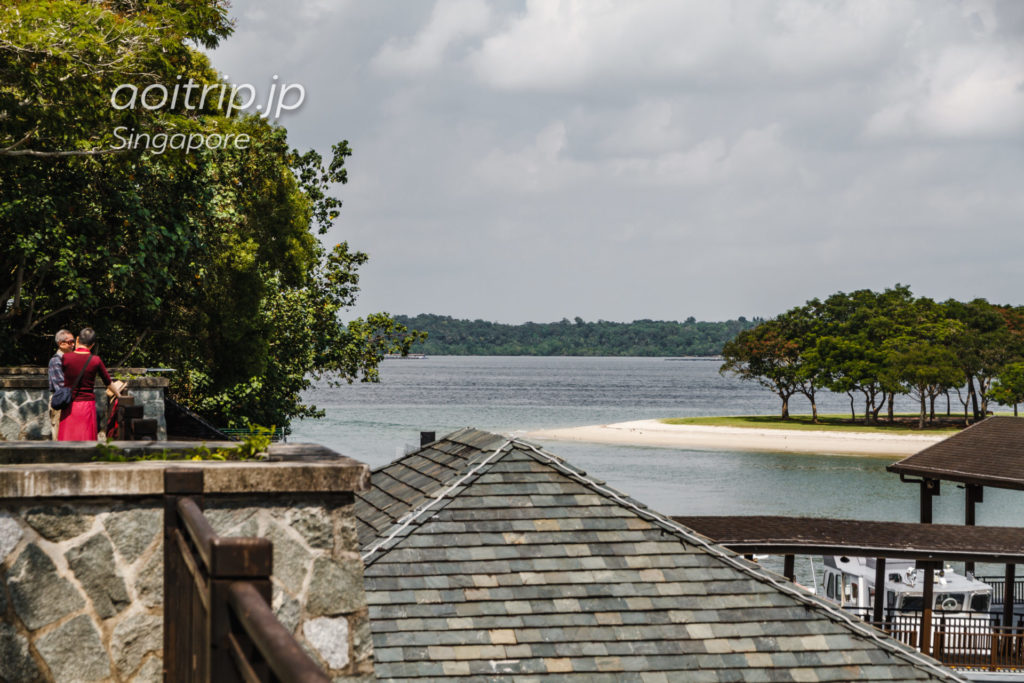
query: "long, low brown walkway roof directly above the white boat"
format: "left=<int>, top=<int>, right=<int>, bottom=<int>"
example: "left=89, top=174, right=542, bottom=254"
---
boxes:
left=673, top=516, right=1024, bottom=564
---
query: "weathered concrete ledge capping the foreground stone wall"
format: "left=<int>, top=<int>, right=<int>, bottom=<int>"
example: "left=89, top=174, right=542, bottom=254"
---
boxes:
left=0, top=441, right=370, bottom=499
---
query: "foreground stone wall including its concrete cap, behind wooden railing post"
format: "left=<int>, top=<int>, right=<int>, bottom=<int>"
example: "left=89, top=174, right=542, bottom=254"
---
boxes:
left=0, top=442, right=373, bottom=681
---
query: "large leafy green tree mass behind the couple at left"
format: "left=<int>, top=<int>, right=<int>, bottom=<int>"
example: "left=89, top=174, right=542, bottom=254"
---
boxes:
left=0, top=0, right=421, bottom=426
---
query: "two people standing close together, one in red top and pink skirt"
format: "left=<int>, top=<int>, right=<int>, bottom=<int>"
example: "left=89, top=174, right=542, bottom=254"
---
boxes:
left=47, top=328, right=124, bottom=441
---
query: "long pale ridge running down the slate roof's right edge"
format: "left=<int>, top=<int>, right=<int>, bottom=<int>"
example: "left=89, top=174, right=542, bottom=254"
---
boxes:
left=510, top=438, right=965, bottom=681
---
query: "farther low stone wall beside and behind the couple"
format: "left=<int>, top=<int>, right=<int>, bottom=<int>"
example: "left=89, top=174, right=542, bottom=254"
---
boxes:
left=0, top=367, right=168, bottom=441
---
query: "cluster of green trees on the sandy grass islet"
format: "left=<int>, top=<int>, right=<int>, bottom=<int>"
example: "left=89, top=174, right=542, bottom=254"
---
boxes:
left=721, top=285, right=1024, bottom=428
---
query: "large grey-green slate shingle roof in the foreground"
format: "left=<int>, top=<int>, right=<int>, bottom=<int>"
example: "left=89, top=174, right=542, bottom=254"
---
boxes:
left=355, top=429, right=961, bottom=682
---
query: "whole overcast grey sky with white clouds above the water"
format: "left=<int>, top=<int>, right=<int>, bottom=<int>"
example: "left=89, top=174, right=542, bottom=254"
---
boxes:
left=203, top=0, right=1024, bottom=323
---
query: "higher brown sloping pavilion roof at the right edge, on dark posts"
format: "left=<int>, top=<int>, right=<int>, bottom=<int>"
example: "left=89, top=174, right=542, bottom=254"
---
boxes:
left=886, top=417, right=1024, bottom=490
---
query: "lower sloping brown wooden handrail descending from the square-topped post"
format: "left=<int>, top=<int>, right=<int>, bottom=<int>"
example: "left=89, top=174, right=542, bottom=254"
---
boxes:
left=227, top=582, right=331, bottom=683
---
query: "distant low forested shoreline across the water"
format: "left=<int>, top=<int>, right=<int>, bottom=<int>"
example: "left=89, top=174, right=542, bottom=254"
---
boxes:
left=394, top=313, right=762, bottom=356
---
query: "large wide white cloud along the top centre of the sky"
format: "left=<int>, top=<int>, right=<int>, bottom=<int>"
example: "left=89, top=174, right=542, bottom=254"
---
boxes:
left=471, top=0, right=908, bottom=91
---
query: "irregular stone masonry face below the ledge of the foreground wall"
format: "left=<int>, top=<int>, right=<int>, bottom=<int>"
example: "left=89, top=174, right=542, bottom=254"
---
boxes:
left=0, top=494, right=374, bottom=682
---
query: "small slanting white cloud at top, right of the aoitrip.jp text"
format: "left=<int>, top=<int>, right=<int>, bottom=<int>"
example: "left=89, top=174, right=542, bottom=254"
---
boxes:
left=373, top=0, right=490, bottom=75
